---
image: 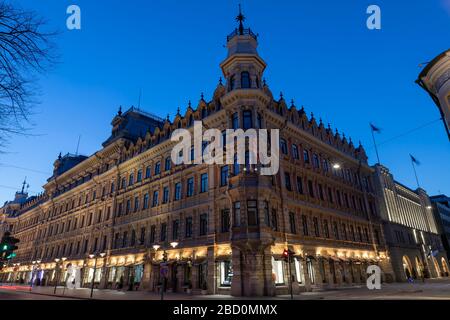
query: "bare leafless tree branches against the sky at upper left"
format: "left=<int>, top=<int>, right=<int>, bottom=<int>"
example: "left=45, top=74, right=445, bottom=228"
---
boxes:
left=0, top=0, right=56, bottom=150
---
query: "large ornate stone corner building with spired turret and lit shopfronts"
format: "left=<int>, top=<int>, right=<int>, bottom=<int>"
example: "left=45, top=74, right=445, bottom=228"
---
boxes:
left=1, top=11, right=446, bottom=296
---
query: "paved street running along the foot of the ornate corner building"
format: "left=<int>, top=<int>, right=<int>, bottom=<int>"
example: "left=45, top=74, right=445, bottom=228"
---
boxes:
left=0, top=279, right=450, bottom=300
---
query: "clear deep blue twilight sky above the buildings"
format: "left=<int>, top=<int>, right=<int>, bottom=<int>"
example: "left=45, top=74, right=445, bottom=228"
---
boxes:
left=0, top=0, right=450, bottom=203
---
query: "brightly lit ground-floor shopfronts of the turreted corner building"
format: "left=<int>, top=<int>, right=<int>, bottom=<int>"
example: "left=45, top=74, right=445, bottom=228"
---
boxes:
left=0, top=243, right=392, bottom=296
